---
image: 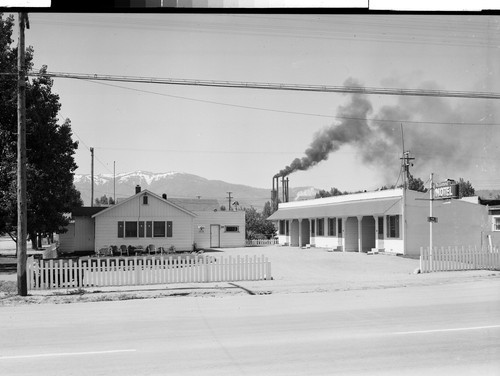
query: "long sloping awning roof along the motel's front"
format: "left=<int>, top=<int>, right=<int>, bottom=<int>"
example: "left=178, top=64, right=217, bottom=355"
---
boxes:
left=267, top=197, right=402, bottom=221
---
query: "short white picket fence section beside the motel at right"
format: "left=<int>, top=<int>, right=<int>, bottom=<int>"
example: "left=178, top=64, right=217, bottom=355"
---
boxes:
left=420, top=247, right=500, bottom=273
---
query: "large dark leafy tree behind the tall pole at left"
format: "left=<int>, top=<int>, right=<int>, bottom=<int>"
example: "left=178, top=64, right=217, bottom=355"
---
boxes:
left=0, top=14, right=83, bottom=249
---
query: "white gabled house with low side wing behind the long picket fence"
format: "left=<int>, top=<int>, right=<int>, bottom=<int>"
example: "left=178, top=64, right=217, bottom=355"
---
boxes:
left=59, top=187, right=245, bottom=252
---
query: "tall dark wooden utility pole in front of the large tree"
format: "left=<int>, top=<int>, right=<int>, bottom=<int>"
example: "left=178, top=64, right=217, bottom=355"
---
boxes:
left=16, top=12, right=29, bottom=296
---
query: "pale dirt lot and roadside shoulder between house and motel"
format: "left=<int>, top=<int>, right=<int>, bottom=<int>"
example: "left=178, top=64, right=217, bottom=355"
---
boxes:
left=0, top=246, right=500, bottom=306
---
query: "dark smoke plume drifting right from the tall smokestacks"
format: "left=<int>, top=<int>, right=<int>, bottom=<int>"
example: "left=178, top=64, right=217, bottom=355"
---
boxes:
left=275, top=79, right=500, bottom=184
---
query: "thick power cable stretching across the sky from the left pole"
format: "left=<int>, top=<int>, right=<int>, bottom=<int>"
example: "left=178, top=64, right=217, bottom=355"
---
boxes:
left=29, top=72, right=500, bottom=99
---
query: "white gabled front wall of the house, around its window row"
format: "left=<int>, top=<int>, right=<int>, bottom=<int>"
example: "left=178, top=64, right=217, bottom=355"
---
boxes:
left=95, top=195, right=194, bottom=250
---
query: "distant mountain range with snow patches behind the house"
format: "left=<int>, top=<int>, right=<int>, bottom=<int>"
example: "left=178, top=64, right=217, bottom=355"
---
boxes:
left=74, top=171, right=318, bottom=210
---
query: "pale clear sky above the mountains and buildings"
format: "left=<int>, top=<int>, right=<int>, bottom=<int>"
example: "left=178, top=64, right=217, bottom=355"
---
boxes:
left=6, top=13, right=500, bottom=191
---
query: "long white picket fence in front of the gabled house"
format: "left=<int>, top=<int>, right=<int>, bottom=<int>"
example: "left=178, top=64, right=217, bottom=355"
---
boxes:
left=27, top=255, right=271, bottom=290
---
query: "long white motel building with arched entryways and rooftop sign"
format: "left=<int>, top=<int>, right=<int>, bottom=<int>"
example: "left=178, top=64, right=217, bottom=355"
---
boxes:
left=268, top=184, right=492, bottom=257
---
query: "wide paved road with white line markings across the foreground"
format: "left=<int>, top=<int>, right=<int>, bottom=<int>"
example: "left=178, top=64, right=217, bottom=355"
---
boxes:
left=0, top=279, right=500, bottom=376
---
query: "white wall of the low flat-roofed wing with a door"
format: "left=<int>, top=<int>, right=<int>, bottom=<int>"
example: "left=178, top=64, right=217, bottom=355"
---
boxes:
left=194, top=211, right=245, bottom=248
